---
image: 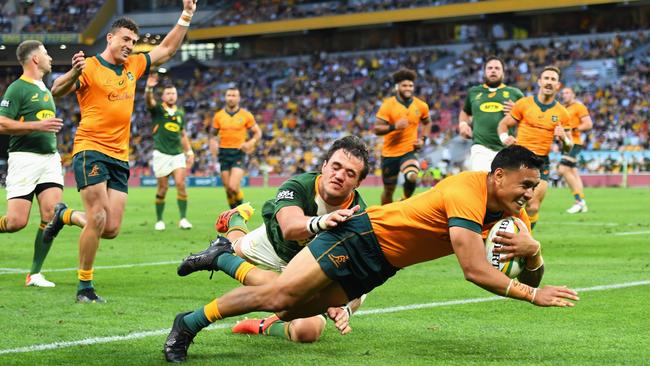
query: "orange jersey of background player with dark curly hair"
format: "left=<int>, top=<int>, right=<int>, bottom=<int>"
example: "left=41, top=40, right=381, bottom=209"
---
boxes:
left=377, top=96, right=429, bottom=157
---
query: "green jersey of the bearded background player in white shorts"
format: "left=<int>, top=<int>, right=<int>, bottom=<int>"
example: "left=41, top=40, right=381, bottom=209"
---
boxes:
left=463, top=84, right=524, bottom=151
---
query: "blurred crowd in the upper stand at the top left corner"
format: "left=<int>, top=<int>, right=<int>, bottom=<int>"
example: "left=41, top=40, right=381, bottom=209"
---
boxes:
left=0, top=0, right=104, bottom=33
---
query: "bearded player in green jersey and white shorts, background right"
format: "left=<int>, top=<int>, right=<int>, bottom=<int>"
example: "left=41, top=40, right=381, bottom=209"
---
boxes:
left=458, top=56, right=524, bottom=172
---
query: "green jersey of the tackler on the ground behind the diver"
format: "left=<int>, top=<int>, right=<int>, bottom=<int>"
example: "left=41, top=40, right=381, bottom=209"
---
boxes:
left=262, top=172, right=366, bottom=262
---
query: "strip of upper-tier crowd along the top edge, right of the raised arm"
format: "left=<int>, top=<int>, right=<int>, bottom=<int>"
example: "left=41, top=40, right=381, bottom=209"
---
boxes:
left=204, top=0, right=482, bottom=26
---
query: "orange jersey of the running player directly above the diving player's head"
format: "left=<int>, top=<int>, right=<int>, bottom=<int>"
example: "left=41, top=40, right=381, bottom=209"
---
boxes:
left=510, top=95, right=569, bottom=156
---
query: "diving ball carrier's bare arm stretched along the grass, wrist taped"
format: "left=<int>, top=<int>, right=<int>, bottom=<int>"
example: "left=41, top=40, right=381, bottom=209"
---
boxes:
left=449, top=226, right=579, bottom=307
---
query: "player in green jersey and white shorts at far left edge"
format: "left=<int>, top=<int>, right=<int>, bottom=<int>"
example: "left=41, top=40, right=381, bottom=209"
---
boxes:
left=0, top=40, right=85, bottom=287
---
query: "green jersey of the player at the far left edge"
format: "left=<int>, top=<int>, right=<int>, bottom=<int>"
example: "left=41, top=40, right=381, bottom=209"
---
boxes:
left=0, top=75, right=56, bottom=154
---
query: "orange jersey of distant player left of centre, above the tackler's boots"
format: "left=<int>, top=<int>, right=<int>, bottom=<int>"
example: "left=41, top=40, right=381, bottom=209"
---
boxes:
left=212, top=108, right=256, bottom=149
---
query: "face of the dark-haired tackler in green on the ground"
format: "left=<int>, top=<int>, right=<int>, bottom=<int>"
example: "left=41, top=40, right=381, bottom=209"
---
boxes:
left=319, top=149, right=363, bottom=203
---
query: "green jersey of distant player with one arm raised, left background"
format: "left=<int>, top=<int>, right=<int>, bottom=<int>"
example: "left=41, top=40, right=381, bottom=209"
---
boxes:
left=149, top=103, right=185, bottom=155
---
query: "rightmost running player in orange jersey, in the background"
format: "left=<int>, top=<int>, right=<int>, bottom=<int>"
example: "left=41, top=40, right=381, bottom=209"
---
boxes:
left=558, top=88, right=593, bottom=214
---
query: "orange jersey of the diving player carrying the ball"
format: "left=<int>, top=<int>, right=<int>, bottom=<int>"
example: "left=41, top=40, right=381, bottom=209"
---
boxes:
left=366, top=172, right=530, bottom=268
